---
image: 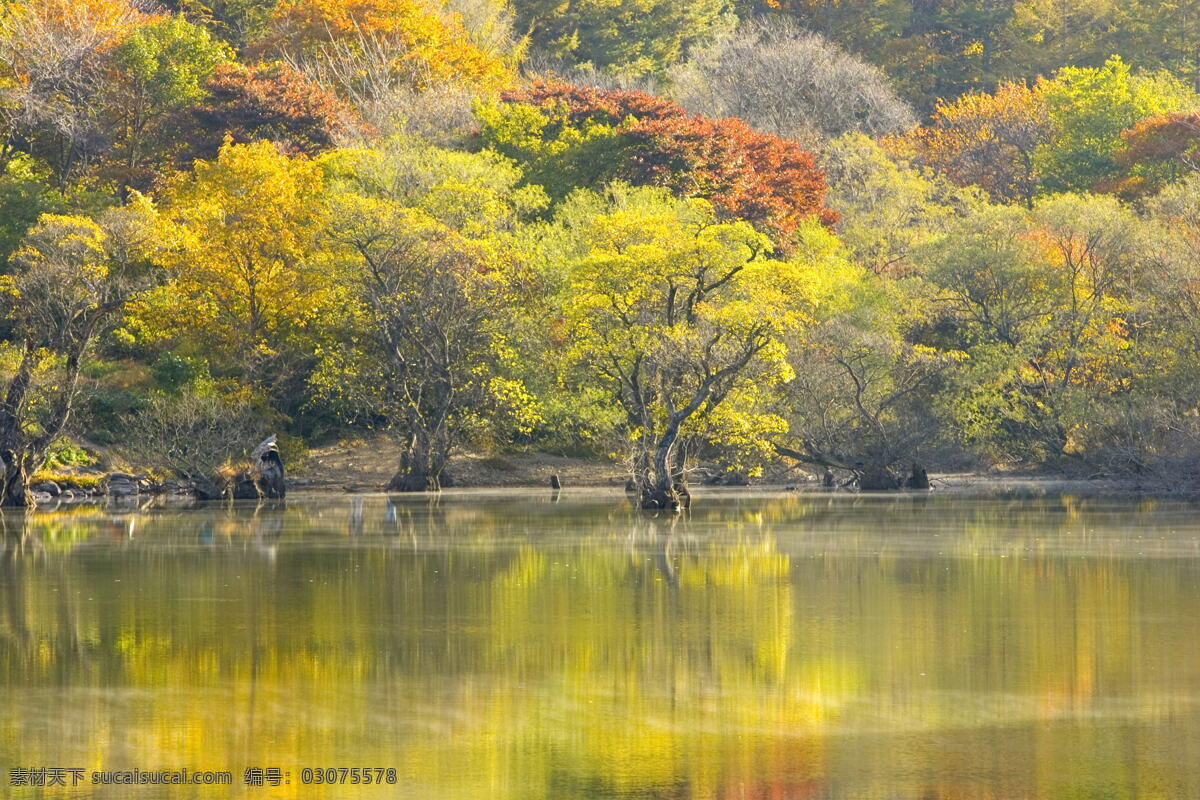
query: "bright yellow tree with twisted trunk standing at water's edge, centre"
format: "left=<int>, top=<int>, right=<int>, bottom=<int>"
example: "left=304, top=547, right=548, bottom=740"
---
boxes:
left=558, top=185, right=820, bottom=509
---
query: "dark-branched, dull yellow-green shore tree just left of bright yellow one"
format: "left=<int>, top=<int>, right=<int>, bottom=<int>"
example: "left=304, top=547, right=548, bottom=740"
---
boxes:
left=319, top=198, right=535, bottom=492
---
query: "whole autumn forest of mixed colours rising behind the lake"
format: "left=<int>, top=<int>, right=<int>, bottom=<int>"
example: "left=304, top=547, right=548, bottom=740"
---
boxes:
left=0, top=0, right=1200, bottom=507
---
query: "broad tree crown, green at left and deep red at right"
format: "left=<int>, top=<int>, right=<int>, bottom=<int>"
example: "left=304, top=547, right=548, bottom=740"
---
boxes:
left=480, top=82, right=836, bottom=247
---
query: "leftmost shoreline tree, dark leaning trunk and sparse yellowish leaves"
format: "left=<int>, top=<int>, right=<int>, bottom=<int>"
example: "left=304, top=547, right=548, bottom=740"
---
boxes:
left=0, top=196, right=157, bottom=506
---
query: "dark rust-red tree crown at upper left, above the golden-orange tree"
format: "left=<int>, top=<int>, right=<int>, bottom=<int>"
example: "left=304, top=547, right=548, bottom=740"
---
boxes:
left=190, top=64, right=354, bottom=158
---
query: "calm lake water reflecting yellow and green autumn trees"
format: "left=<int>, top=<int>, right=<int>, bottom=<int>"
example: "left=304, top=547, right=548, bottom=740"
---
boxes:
left=0, top=491, right=1200, bottom=800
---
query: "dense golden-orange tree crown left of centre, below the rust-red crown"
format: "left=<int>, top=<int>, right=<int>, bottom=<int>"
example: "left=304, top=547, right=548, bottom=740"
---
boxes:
left=133, top=142, right=336, bottom=398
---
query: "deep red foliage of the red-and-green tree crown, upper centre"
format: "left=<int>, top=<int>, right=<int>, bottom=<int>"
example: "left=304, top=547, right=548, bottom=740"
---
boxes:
left=504, top=82, right=838, bottom=245
